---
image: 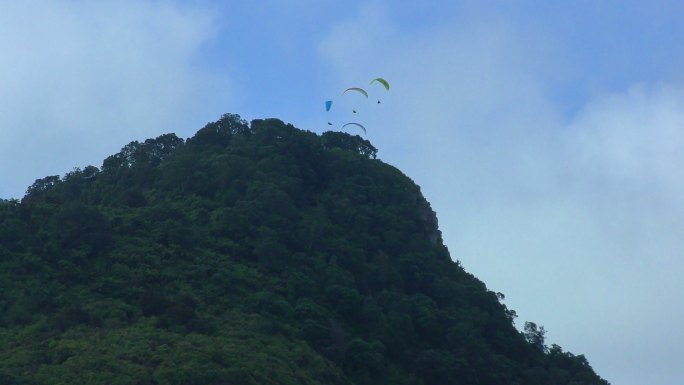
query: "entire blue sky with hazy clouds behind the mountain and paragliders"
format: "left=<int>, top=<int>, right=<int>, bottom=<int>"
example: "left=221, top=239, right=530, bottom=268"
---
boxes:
left=0, top=0, right=684, bottom=385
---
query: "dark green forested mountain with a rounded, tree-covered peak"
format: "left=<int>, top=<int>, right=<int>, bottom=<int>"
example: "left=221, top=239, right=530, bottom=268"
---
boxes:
left=0, top=115, right=608, bottom=385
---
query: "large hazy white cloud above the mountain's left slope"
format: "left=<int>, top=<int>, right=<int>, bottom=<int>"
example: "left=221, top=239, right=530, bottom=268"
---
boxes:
left=0, top=1, right=220, bottom=197
